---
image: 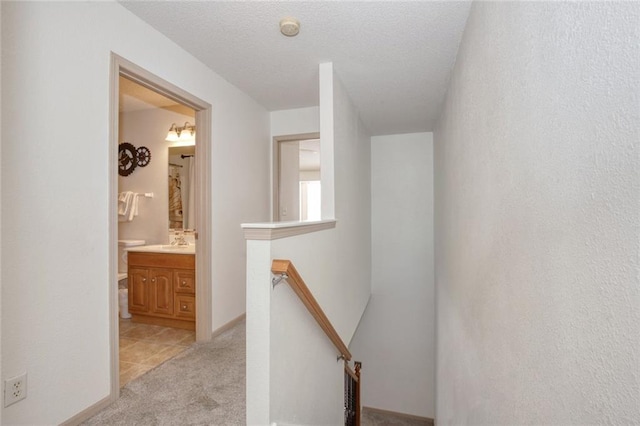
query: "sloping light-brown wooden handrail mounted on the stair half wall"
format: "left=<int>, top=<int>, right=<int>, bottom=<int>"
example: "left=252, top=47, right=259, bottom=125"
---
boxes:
left=271, top=259, right=351, bottom=361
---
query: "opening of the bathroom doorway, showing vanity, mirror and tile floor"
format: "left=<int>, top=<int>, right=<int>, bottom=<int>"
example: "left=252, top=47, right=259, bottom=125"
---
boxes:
left=118, top=75, right=197, bottom=387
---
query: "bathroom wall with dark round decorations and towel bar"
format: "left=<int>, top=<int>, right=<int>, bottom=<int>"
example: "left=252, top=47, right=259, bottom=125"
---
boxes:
left=118, top=108, right=192, bottom=244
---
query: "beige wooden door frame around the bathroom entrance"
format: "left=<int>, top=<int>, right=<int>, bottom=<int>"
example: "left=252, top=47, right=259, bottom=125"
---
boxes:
left=109, top=52, right=213, bottom=400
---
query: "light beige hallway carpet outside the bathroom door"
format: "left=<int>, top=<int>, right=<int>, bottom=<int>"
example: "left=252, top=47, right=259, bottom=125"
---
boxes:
left=82, top=321, right=246, bottom=426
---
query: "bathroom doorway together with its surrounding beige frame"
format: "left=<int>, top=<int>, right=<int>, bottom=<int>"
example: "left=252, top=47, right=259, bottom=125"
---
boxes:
left=109, top=54, right=212, bottom=400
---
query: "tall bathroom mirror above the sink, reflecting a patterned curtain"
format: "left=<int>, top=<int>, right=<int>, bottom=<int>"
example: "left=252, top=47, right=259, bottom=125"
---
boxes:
left=168, top=145, right=196, bottom=229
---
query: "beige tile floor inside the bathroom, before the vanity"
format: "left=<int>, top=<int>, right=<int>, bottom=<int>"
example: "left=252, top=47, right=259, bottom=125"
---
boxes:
left=120, top=319, right=196, bottom=387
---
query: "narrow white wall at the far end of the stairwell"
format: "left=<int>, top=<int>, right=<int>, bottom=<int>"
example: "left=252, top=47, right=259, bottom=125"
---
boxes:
left=350, top=133, right=435, bottom=418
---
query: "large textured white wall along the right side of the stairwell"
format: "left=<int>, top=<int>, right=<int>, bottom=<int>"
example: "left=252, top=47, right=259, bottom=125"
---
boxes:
left=434, top=2, right=640, bottom=425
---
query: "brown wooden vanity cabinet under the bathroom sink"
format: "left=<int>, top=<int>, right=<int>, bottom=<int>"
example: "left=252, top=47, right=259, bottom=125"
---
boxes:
left=128, top=251, right=196, bottom=330
